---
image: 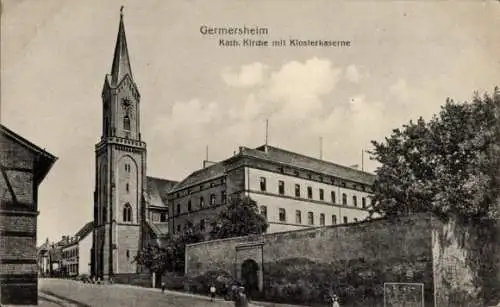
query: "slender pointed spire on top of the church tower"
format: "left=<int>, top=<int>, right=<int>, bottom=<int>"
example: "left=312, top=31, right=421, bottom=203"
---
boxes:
left=111, top=5, right=132, bottom=85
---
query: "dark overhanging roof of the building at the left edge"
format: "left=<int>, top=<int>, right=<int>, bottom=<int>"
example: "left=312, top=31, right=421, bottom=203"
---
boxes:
left=0, top=125, right=57, bottom=183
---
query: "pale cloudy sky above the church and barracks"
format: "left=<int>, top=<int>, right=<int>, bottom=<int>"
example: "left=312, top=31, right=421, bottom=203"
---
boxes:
left=1, top=0, right=500, bottom=242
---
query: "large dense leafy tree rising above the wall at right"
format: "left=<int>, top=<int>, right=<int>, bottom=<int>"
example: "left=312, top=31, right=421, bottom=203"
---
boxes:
left=371, top=88, right=500, bottom=224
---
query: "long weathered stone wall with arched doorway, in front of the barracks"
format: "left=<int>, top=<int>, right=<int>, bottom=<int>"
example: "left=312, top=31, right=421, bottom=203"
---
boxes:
left=186, top=215, right=434, bottom=306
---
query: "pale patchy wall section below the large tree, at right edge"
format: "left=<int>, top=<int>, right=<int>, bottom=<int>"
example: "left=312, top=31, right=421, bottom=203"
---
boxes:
left=432, top=220, right=500, bottom=307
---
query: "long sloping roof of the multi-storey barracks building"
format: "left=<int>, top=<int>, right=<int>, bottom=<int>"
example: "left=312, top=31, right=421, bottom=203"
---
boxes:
left=172, top=145, right=375, bottom=191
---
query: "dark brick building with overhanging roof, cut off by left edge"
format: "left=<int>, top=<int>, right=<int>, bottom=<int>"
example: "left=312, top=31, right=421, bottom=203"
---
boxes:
left=0, top=125, right=57, bottom=305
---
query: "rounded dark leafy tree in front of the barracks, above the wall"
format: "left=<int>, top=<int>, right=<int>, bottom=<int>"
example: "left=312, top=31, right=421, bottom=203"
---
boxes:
left=210, top=196, right=269, bottom=239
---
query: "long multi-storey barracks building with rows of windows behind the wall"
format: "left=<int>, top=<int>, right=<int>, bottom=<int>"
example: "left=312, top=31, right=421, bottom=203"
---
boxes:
left=169, top=145, right=374, bottom=233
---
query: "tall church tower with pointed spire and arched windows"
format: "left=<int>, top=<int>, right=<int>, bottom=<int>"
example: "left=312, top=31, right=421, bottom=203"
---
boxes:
left=92, top=7, right=146, bottom=279
